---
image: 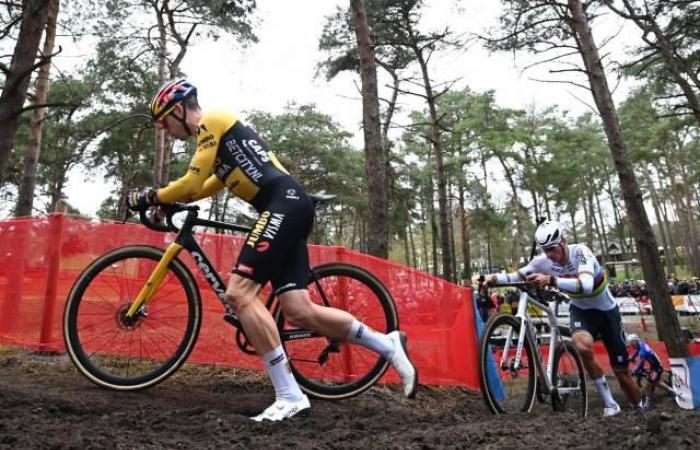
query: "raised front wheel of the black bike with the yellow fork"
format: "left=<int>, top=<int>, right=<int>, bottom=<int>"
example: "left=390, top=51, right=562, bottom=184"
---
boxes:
left=63, top=245, right=202, bottom=391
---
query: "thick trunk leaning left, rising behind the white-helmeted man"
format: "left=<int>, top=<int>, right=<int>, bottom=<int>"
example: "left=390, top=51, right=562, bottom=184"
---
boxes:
left=568, top=0, right=689, bottom=357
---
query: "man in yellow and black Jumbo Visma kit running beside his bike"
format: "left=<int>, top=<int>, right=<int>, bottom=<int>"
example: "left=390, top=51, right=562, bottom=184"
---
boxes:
left=127, top=79, right=418, bottom=422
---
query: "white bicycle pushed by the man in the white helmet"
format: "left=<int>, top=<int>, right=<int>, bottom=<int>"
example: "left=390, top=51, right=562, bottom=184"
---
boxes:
left=479, top=282, right=588, bottom=417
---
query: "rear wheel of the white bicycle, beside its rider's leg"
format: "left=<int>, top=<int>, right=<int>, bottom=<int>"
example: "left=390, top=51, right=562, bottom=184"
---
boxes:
left=552, top=341, right=588, bottom=417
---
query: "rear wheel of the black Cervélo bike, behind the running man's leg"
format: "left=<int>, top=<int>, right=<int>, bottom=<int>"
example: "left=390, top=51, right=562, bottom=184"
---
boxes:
left=276, top=263, right=399, bottom=400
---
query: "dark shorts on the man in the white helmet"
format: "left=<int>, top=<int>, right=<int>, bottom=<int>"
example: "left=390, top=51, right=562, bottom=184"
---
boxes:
left=569, top=305, right=629, bottom=369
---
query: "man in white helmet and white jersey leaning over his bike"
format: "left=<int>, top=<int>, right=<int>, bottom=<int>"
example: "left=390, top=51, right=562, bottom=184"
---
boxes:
left=475, top=220, right=644, bottom=416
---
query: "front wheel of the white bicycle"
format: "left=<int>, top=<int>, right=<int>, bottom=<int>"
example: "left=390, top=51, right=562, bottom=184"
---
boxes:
left=479, top=314, right=537, bottom=414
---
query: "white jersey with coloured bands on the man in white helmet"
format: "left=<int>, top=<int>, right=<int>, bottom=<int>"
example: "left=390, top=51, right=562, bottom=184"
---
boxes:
left=518, top=244, right=617, bottom=311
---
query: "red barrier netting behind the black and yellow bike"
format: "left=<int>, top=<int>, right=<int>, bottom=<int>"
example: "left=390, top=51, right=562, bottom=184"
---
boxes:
left=0, top=214, right=479, bottom=389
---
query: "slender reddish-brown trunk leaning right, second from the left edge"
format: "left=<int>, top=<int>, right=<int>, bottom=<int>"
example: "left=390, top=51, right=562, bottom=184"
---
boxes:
left=15, top=0, right=58, bottom=217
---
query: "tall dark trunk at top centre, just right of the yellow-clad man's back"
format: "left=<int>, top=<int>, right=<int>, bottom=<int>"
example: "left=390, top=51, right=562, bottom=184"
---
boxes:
left=350, top=0, right=389, bottom=258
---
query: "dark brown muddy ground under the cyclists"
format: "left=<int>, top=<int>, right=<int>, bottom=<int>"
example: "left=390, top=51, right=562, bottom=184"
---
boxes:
left=0, top=349, right=700, bottom=449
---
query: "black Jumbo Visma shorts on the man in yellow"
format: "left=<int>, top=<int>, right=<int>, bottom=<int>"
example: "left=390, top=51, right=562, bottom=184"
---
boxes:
left=232, top=177, right=314, bottom=294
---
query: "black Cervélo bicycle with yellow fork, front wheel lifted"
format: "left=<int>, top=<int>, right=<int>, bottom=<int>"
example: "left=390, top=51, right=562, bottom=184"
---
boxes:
left=63, top=194, right=399, bottom=399
